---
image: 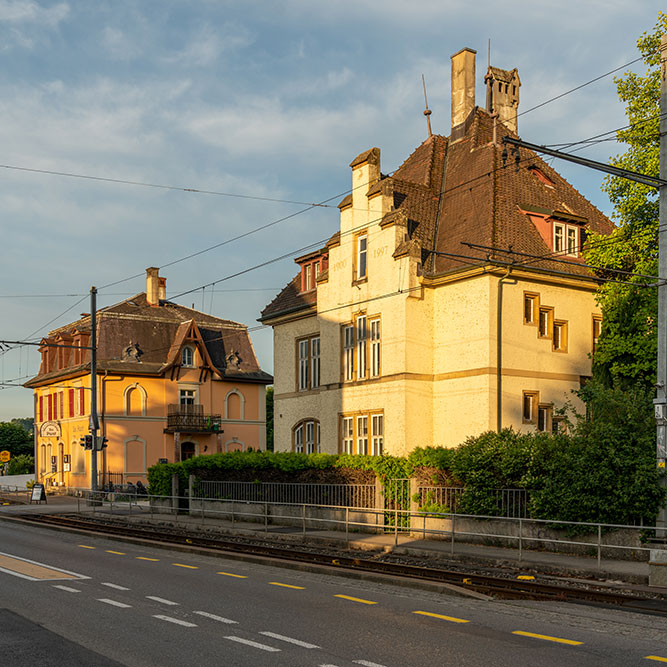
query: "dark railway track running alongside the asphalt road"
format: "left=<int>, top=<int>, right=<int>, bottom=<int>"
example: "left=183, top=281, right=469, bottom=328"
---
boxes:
left=17, top=514, right=667, bottom=617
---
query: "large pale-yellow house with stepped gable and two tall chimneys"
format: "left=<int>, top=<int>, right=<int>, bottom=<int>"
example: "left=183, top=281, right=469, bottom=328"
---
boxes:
left=260, top=49, right=612, bottom=455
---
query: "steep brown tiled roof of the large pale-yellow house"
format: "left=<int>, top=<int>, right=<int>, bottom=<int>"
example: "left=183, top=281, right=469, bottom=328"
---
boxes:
left=261, top=107, right=613, bottom=320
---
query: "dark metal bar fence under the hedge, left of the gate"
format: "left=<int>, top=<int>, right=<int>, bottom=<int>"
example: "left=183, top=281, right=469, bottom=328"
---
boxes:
left=196, top=480, right=376, bottom=508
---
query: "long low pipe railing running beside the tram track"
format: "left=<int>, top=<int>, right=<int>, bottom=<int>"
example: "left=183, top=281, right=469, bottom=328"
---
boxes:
left=70, top=491, right=666, bottom=569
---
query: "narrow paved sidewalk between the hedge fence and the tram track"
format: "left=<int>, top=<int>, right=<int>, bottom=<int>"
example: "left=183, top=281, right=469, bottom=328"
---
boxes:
left=0, top=496, right=649, bottom=586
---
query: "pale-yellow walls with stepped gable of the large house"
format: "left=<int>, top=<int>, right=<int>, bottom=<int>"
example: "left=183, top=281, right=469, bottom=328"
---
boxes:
left=272, top=148, right=599, bottom=455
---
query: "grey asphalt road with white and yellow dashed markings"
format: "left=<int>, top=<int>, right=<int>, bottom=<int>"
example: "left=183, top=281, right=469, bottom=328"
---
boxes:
left=0, top=522, right=667, bottom=667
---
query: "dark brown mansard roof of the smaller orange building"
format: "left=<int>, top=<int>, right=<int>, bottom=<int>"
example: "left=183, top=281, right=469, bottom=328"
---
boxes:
left=26, top=293, right=272, bottom=386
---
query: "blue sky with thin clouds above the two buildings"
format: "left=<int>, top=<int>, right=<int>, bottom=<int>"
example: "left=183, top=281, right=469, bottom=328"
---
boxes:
left=0, top=0, right=664, bottom=420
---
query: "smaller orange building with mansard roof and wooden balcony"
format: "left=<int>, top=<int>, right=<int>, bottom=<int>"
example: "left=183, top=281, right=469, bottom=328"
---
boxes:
left=25, top=268, right=272, bottom=487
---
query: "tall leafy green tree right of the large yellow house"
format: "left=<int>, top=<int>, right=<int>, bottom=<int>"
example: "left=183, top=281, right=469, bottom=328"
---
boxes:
left=585, top=12, right=667, bottom=388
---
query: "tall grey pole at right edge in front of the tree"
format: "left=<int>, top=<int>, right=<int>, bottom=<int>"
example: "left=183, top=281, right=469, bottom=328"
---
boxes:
left=653, top=34, right=667, bottom=536
